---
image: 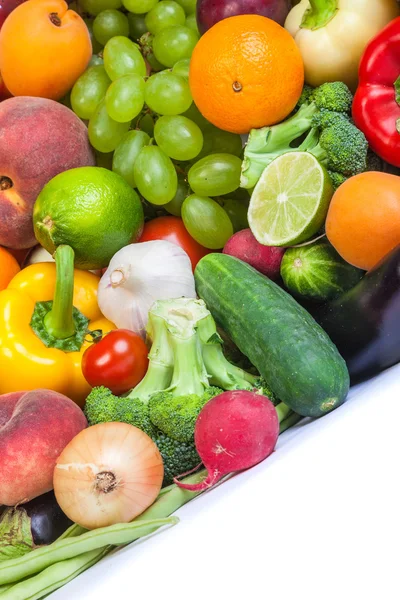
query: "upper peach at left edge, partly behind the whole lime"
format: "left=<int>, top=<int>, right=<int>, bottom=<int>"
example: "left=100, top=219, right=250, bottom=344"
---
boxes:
left=0, top=96, right=95, bottom=248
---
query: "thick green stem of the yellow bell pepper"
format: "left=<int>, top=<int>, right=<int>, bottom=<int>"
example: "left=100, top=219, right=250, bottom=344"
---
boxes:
left=44, top=246, right=75, bottom=340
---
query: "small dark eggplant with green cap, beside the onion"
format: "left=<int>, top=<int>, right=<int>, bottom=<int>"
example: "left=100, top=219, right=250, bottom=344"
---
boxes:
left=0, top=492, right=72, bottom=561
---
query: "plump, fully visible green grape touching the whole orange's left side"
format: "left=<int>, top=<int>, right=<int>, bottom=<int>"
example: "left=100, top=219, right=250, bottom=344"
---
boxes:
left=145, top=71, right=192, bottom=115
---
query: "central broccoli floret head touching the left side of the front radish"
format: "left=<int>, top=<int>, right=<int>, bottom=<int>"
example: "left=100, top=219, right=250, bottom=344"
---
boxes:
left=149, top=387, right=222, bottom=443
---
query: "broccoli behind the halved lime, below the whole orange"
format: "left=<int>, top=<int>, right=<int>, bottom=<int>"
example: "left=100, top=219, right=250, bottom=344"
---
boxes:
left=241, top=82, right=368, bottom=189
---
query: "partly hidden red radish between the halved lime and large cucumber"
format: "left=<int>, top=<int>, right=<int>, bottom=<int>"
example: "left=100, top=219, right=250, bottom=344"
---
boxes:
left=223, top=229, right=285, bottom=279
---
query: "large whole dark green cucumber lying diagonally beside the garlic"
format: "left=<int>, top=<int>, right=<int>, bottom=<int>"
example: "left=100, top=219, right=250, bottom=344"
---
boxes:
left=195, top=254, right=349, bottom=417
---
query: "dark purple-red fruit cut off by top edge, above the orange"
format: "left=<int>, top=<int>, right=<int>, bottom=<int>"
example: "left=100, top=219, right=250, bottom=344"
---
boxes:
left=197, top=0, right=291, bottom=34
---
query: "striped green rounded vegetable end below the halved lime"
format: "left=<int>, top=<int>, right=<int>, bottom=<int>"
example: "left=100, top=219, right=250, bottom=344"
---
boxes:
left=281, top=240, right=364, bottom=302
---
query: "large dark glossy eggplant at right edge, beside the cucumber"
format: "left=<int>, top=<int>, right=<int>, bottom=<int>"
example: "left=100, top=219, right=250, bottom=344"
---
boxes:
left=312, top=245, right=400, bottom=384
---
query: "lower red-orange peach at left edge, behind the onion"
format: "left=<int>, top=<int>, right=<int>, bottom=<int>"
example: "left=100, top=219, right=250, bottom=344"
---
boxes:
left=0, top=389, right=87, bottom=506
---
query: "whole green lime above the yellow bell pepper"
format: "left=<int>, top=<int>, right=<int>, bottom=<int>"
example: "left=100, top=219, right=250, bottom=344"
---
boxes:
left=33, top=167, right=143, bottom=269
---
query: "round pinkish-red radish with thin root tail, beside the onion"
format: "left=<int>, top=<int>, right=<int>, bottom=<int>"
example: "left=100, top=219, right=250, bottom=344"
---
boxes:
left=174, top=390, right=279, bottom=492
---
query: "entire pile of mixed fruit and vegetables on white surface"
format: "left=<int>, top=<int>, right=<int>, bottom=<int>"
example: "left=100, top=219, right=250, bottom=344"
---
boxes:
left=0, top=0, right=400, bottom=600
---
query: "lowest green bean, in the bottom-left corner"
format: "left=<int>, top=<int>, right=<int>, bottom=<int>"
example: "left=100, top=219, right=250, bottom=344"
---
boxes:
left=1, top=546, right=111, bottom=600
